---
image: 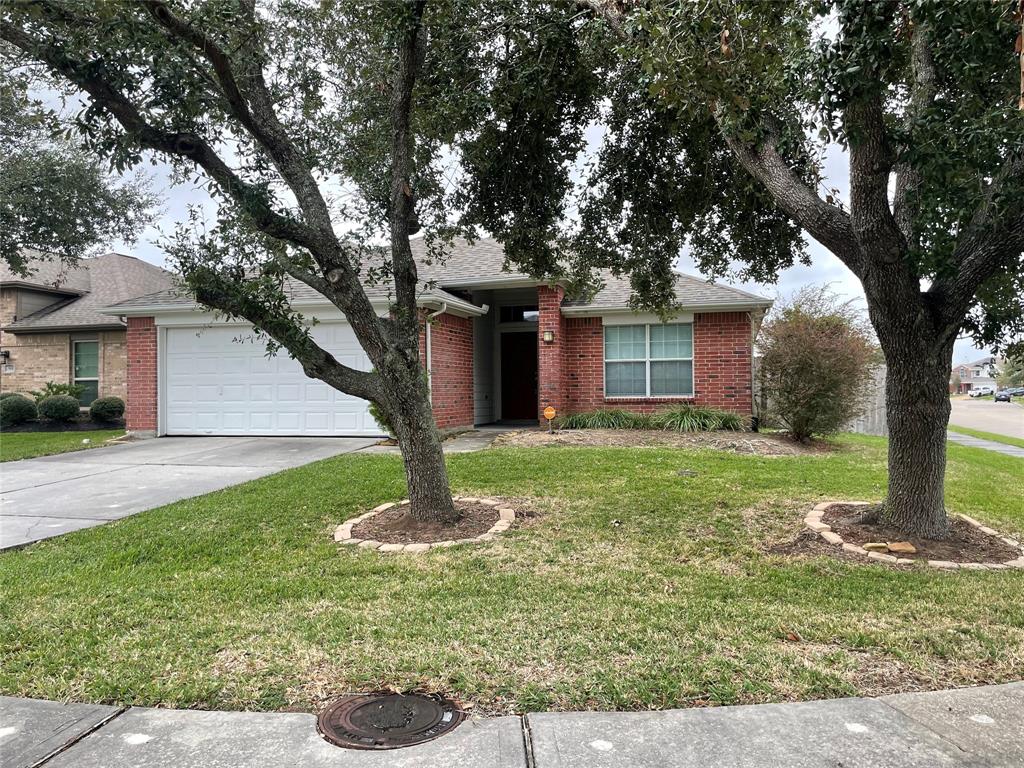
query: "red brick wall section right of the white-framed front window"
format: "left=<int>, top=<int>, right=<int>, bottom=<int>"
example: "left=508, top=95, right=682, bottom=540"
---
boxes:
left=693, top=312, right=754, bottom=414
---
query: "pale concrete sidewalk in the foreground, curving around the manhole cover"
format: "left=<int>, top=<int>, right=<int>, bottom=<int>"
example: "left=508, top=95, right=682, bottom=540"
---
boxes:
left=0, top=683, right=1024, bottom=768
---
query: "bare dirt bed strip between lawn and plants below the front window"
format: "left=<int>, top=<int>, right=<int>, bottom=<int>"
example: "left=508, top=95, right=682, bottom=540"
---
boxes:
left=493, top=429, right=833, bottom=456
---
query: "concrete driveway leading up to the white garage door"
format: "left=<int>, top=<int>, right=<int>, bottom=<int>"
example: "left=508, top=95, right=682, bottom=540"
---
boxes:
left=0, top=437, right=377, bottom=549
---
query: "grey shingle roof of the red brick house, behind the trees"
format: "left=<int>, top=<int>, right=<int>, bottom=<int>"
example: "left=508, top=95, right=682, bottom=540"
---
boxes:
left=105, top=238, right=771, bottom=309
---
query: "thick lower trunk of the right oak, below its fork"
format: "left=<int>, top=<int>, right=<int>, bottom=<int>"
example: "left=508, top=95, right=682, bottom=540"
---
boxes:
left=882, top=333, right=952, bottom=539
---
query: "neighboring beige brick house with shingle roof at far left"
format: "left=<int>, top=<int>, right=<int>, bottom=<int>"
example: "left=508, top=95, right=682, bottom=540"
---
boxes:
left=0, top=253, right=173, bottom=406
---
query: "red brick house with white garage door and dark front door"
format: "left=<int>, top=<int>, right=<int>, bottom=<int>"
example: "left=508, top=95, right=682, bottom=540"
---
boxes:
left=104, top=239, right=771, bottom=435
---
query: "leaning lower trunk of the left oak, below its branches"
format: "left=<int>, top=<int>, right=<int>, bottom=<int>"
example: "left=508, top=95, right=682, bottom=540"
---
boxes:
left=381, top=367, right=460, bottom=522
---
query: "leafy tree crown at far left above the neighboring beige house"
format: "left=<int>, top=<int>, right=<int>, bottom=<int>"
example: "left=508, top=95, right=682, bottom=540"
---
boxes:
left=0, top=78, right=157, bottom=273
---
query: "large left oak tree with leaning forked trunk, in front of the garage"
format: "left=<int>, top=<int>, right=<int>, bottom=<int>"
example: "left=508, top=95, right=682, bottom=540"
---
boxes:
left=0, top=0, right=593, bottom=521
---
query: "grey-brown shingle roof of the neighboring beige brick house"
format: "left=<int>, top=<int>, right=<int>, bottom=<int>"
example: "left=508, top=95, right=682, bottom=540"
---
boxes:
left=0, top=253, right=174, bottom=333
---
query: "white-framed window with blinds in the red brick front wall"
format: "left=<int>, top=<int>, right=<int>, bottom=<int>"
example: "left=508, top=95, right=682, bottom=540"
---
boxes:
left=604, top=323, right=693, bottom=397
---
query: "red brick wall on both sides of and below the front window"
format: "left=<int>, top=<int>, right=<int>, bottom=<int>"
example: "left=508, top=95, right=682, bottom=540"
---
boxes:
left=562, top=312, right=753, bottom=415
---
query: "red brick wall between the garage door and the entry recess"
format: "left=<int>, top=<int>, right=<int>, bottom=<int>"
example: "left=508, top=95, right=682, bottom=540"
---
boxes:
left=420, top=314, right=473, bottom=429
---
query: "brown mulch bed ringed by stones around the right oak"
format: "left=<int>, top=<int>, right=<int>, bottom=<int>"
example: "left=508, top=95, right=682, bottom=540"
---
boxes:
left=821, top=504, right=1021, bottom=563
